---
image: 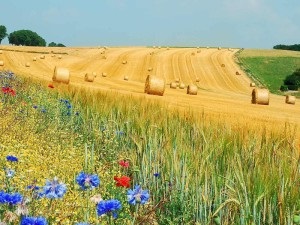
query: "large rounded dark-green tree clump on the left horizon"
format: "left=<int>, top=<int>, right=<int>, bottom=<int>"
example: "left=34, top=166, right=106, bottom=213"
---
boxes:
left=8, top=30, right=46, bottom=46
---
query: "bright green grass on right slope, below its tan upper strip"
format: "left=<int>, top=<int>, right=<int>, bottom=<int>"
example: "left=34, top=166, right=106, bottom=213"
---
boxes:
left=237, top=49, right=300, bottom=94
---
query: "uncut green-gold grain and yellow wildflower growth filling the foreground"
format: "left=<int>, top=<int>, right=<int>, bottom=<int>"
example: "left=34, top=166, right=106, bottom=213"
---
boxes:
left=0, top=71, right=300, bottom=225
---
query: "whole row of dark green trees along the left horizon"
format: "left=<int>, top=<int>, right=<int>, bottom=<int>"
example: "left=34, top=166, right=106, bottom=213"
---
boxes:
left=0, top=25, right=66, bottom=47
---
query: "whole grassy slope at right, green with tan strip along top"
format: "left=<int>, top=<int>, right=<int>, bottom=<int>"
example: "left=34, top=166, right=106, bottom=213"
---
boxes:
left=237, top=50, right=300, bottom=94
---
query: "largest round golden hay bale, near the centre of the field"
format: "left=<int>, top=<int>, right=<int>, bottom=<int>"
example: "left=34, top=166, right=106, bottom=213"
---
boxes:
left=145, top=75, right=165, bottom=96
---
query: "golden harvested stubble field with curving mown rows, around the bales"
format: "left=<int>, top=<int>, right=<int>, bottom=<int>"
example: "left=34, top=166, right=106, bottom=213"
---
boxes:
left=0, top=46, right=300, bottom=136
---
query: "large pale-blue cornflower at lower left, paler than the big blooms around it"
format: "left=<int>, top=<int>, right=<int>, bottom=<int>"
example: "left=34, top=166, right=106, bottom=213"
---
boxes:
left=40, top=177, right=67, bottom=199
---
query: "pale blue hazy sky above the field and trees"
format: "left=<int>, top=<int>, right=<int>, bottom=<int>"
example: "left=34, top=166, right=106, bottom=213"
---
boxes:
left=0, top=0, right=300, bottom=48
